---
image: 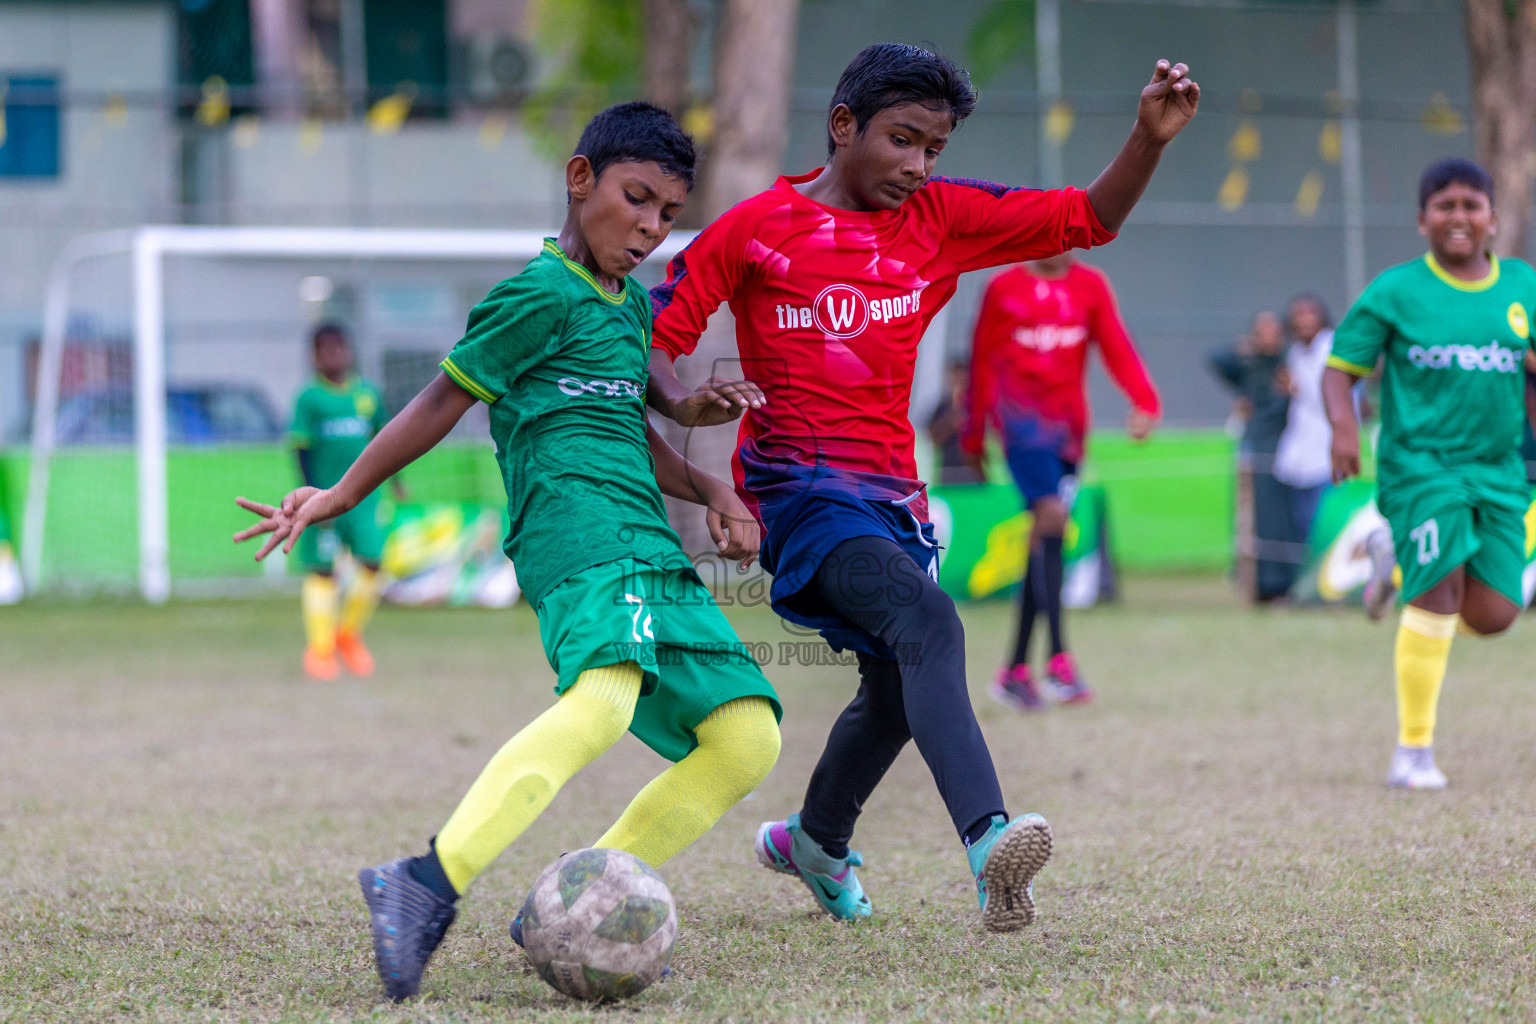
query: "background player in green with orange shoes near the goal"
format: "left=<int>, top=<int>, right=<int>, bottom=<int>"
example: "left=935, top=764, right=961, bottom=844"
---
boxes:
left=289, top=324, right=404, bottom=679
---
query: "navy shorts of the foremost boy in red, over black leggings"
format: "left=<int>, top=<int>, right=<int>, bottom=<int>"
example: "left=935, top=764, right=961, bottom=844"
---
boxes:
left=760, top=493, right=938, bottom=662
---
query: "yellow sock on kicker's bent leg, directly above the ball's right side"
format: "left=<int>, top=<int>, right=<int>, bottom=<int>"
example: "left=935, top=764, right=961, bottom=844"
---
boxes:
left=593, top=697, right=779, bottom=866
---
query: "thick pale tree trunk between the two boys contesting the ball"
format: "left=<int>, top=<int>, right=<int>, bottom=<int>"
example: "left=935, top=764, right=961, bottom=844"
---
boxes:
left=662, top=0, right=800, bottom=561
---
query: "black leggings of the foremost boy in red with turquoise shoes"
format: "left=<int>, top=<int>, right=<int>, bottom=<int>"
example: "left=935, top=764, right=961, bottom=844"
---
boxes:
left=800, top=537, right=1005, bottom=857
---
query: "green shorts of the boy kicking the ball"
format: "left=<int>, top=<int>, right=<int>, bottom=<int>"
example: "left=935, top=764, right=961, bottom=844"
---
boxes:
left=539, top=559, right=783, bottom=761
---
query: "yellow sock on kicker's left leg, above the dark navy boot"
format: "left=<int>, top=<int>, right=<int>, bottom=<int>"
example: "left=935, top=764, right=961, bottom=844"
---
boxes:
left=436, top=662, right=642, bottom=892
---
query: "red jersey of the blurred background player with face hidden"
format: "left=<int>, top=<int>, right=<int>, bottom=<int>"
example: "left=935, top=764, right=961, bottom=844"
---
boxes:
left=960, top=263, right=1161, bottom=462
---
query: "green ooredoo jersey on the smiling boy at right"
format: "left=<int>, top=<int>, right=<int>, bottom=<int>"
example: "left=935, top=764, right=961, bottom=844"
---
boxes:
left=1329, top=253, right=1536, bottom=477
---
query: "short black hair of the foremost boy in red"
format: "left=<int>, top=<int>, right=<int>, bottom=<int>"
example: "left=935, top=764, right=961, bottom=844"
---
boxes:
left=826, top=43, right=975, bottom=157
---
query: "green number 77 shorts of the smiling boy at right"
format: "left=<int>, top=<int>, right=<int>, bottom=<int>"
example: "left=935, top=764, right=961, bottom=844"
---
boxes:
left=1376, top=453, right=1531, bottom=605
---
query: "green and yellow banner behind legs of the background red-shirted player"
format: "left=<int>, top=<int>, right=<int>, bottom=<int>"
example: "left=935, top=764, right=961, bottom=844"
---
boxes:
left=928, top=484, right=1115, bottom=608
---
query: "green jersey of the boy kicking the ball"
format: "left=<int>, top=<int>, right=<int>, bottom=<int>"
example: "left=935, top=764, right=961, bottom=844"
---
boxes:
left=442, top=238, right=691, bottom=608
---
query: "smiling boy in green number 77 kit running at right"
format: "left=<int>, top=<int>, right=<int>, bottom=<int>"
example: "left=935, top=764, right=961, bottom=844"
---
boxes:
left=1322, top=160, right=1536, bottom=789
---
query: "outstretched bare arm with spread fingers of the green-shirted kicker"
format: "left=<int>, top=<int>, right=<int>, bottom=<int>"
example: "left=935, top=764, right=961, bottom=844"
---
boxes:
left=235, top=373, right=476, bottom=562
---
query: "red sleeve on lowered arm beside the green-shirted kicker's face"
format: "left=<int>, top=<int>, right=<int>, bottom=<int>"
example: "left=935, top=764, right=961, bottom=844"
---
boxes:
left=651, top=203, right=746, bottom=359
